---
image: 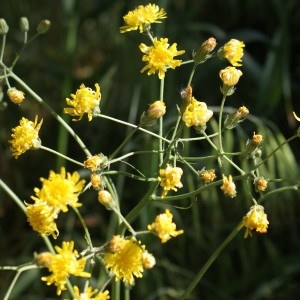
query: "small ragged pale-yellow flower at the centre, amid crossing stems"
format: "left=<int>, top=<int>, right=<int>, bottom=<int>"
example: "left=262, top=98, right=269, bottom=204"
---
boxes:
left=158, top=165, right=183, bottom=197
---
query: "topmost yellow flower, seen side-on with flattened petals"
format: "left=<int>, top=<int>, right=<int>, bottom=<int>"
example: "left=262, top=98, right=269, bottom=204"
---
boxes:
left=120, top=4, right=167, bottom=33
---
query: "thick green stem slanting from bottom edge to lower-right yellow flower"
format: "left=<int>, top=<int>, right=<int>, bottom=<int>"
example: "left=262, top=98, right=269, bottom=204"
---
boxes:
left=179, top=224, right=240, bottom=300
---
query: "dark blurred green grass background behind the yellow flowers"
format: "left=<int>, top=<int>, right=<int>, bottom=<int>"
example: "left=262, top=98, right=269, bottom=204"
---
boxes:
left=0, top=0, right=300, bottom=300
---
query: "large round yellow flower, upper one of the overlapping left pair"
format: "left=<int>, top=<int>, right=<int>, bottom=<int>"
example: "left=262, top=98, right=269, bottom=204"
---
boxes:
left=31, top=167, right=85, bottom=217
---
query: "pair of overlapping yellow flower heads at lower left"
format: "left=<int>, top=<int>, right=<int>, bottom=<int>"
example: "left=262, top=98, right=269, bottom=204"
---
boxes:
left=26, top=168, right=85, bottom=238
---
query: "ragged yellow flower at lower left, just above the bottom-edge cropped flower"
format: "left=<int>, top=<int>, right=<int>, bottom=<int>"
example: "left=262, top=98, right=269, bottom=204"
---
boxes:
left=42, top=241, right=91, bottom=295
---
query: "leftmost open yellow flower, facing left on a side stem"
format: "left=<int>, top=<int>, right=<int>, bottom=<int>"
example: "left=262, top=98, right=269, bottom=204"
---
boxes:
left=9, top=116, right=43, bottom=158
